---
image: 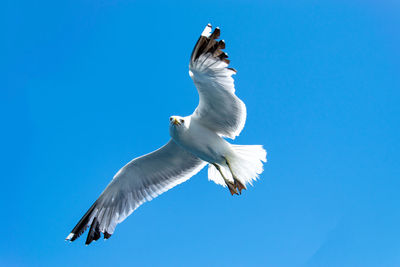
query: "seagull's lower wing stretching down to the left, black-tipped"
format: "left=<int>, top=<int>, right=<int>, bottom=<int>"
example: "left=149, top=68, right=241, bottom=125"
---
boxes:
left=67, top=140, right=205, bottom=245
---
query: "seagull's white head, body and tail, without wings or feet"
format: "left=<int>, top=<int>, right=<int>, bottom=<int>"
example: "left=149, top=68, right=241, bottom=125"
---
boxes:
left=169, top=115, right=266, bottom=187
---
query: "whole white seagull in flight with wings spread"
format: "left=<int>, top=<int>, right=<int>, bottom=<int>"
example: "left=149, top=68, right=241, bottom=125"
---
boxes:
left=66, top=24, right=267, bottom=245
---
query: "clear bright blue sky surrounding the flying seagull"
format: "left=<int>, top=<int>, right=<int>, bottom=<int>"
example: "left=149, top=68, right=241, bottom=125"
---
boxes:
left=0, top=0, right=400, bottom=266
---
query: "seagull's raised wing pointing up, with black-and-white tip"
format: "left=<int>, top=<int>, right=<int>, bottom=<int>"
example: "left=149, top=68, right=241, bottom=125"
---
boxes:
left=189, top=24, right=246, bottom=139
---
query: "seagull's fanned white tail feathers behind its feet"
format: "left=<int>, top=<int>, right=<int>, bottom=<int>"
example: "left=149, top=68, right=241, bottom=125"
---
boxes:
left=208, top=145, right=267, bottom=186
